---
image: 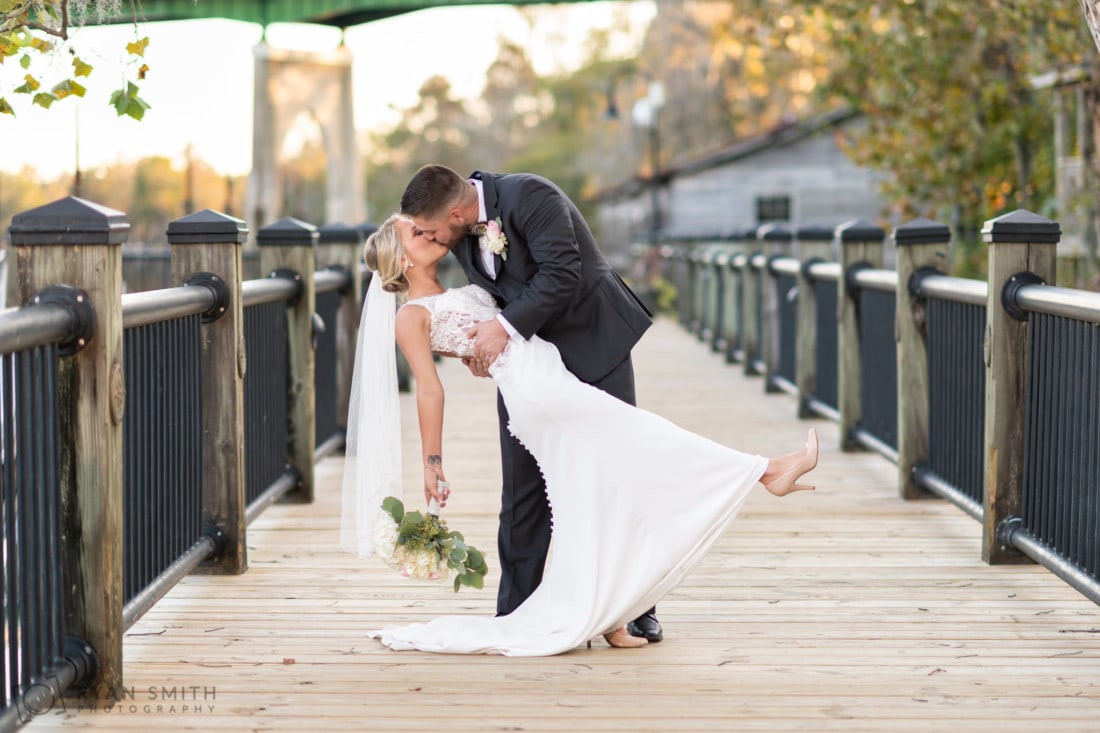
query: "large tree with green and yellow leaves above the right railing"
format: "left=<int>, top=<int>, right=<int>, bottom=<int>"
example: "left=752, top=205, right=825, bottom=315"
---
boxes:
left=802, top=0, right=1095, bottom=234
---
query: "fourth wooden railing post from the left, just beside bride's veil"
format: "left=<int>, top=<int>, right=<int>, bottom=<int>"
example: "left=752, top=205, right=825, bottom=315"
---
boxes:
left=317, top=225, right=365, bottom=427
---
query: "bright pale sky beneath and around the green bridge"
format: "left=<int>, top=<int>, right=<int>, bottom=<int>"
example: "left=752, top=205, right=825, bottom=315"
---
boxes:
left=0, top=0, right=655, bottom=179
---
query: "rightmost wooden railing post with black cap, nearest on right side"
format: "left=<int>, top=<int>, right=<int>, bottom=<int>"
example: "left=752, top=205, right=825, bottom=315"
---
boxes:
left=981, top=209, right=1062, bottom=564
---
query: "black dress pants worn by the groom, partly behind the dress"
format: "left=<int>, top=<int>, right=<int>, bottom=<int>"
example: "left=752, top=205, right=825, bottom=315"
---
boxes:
left=496, top=355, right=636, bottom=616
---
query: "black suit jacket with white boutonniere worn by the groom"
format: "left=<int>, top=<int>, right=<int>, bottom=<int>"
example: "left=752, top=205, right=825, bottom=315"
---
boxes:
left=454, top=172, right=652, bottom=382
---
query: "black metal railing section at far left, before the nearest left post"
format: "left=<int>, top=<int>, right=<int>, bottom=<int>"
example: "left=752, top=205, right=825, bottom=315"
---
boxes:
left=0, top=286, right=95, bottom=730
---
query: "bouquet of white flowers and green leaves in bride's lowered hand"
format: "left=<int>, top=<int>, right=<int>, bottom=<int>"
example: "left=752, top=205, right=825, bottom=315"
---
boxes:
left=374, top=496, right=488, bottom=593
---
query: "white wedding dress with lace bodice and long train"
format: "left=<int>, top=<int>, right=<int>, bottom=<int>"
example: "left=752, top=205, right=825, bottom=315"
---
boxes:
left=371, top=285, right=768, bottom=656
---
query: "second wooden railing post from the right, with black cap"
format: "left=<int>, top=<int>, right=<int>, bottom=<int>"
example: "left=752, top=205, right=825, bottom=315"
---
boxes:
left=893, top=219, right=952, bottom=499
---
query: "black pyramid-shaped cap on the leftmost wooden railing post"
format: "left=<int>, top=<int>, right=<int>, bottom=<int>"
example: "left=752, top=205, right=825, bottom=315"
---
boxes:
left=8, top=196, right=130, bottom=247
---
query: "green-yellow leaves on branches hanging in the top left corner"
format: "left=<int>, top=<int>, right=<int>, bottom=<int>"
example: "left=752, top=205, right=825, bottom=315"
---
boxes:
left=0, top=0, right=149, bottom=120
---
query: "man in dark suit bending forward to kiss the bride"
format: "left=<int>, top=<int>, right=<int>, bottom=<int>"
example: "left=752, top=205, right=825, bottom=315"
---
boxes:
left=402, top=165, right=662, bottom=642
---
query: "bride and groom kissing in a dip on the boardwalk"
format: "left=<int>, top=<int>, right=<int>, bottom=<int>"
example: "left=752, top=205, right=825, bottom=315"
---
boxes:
left=341, top=165, right=817, bottom=656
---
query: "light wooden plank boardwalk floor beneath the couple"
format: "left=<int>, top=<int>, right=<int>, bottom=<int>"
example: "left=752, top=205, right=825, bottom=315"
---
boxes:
left=26, top=321, right=1100, bottom=732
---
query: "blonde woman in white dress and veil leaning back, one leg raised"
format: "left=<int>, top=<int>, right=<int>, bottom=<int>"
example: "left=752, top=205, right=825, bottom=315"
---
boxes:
left=341, top=215, right=817, bottom=656
